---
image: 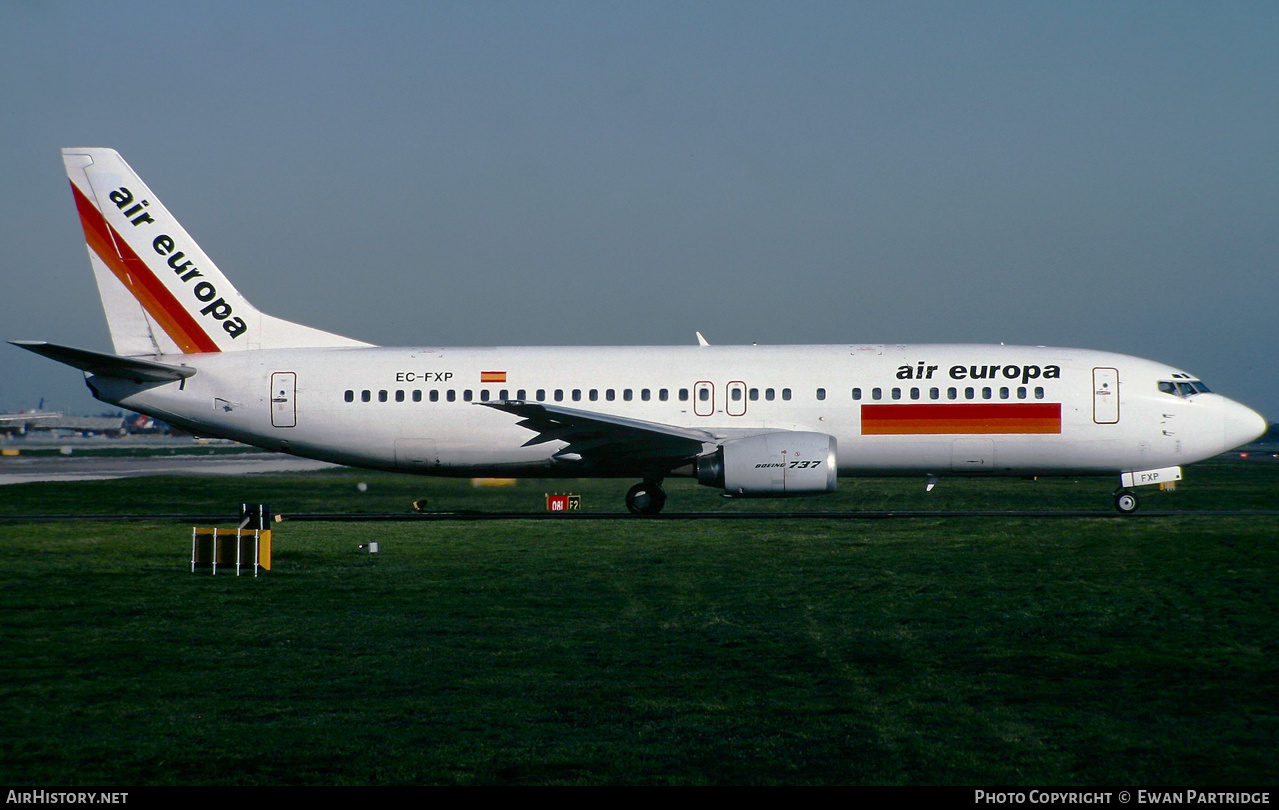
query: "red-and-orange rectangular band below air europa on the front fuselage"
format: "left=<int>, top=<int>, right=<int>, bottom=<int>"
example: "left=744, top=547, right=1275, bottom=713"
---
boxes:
left=862, top=402, right=1062, bottom=436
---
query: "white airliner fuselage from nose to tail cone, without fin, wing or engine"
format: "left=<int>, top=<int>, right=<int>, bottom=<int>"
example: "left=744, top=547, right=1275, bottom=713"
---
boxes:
left=91, top=344, right=1265, bottom=476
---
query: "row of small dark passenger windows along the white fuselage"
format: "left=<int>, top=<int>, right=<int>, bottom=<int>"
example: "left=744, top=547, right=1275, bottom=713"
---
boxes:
left=344, top=385, right=1044, bottom=402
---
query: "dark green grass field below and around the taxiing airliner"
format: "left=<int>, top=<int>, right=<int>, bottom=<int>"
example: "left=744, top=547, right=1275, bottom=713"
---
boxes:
left=0, top=462, right=1279, bottom=786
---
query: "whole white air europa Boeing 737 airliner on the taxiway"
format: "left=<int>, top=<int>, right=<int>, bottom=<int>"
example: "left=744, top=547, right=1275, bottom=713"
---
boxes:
left=15, top=148, right=1266, bottom=514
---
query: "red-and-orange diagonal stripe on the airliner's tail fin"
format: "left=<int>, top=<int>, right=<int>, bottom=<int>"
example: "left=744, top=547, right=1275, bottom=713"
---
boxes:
left=72, top=183, right=220, bottom=354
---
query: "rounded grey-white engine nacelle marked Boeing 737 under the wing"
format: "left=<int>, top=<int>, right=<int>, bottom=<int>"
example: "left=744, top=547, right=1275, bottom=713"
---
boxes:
left=697, top=430, right=838, bottom=498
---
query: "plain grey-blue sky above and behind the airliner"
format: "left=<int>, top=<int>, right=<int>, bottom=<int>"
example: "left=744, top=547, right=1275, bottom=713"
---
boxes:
left=0, top=1, right=1279, bottom=420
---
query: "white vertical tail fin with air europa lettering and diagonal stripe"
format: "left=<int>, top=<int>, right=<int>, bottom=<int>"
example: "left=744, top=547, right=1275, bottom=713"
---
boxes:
left=63, top=148, right=370, bottom=357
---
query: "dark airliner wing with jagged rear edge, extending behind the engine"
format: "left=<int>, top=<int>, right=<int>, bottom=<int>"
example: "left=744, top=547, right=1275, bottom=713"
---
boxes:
left=476, top=399, right=716, bottom=466
